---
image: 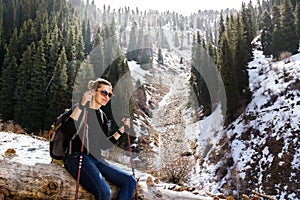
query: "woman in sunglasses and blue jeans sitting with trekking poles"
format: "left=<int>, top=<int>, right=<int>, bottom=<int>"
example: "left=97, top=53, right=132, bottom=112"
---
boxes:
left=61, top=78, right=136, bottom=200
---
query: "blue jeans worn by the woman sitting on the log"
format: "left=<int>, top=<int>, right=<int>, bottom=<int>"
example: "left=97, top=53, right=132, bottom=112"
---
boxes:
left=64, top=153, right=136, bottom=200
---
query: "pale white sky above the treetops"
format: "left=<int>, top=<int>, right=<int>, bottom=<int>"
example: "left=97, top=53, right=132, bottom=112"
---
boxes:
left=95, top=0, right=256, bottom=15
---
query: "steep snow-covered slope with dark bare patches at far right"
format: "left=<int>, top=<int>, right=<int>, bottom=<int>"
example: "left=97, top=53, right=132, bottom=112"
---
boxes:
left=198, top=47, right=300, bottom=199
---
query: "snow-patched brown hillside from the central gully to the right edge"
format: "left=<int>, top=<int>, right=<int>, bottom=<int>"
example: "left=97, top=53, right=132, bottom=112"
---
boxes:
left=101, top=33, right=300, bottom=199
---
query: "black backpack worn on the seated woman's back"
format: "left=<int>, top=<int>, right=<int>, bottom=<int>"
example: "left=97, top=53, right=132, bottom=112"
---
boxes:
left=48, top=108, right=74, bottom=160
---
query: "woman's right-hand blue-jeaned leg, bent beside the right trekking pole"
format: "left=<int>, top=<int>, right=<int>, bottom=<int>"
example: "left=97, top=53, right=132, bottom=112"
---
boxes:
left=97, top=159, right=136, bottom=200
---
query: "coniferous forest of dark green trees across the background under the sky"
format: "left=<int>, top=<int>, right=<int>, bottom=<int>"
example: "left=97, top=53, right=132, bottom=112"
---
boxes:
left=0, top=0, right=300, bottom=133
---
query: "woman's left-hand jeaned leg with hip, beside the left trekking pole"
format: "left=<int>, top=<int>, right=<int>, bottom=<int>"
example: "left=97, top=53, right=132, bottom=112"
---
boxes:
left=65, top=154, right=111, bottom=200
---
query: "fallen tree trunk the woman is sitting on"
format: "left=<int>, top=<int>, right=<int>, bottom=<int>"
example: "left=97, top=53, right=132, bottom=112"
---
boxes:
left=0, top=160, right=117, bottom=200
